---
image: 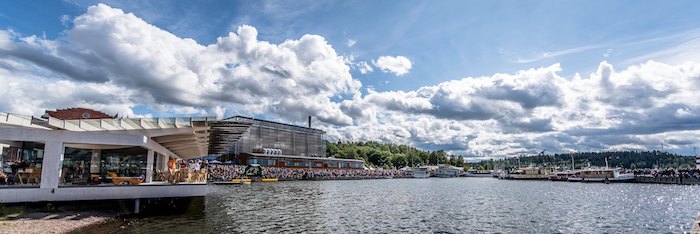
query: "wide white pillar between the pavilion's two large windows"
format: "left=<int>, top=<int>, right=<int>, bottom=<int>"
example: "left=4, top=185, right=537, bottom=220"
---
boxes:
left=39, top=141, right=65, bottom=189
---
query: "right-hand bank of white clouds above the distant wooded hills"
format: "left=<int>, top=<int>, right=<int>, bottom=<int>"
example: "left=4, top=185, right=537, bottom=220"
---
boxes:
left=329, top=61, right=700, bottom=156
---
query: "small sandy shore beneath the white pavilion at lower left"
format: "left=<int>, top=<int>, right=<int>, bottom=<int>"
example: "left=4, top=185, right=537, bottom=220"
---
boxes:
left=0, top=211, right=117, bottom=234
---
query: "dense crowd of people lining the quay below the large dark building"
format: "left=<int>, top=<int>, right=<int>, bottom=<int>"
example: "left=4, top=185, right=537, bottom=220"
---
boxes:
left=209, top=164, right=411, bottom=181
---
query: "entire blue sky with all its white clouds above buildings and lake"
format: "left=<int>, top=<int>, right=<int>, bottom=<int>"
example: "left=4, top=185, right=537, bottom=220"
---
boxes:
left=0, top=0, right=700, bottom=159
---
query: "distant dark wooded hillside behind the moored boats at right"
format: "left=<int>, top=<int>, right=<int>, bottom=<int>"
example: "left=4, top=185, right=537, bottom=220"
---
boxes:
left=469, top=151, right=695, bottom=169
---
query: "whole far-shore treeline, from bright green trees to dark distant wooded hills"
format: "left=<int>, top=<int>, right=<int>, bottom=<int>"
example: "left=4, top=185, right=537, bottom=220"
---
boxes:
left=326, top=141, right=695, bottom=170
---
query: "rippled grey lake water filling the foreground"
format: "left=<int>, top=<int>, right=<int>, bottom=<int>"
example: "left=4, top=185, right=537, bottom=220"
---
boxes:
left=75, top=178, right=700, bottom=233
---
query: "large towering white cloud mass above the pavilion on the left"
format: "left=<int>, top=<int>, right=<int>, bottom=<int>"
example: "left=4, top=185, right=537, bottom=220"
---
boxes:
left=0, top=4, right=361, bottom=125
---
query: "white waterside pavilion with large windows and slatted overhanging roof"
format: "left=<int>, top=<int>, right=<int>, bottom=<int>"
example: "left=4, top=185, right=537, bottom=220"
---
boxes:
left=0, top=109, right=238, bottom=203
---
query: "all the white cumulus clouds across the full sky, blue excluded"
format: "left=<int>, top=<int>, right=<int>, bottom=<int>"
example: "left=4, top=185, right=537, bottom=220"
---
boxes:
left=0, top=4, right=700, bottom=157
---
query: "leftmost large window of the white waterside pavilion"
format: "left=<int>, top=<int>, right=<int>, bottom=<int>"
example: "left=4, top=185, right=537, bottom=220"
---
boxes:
left=0, top=142, right=44, bottom=187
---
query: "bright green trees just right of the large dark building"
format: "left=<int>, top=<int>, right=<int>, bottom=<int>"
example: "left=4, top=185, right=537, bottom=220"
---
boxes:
left=326, top=141, right=465, bottom=168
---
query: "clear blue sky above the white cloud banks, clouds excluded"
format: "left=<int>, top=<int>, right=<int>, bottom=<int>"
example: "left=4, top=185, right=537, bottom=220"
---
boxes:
left=5, top=0, right=700, bottom=91
